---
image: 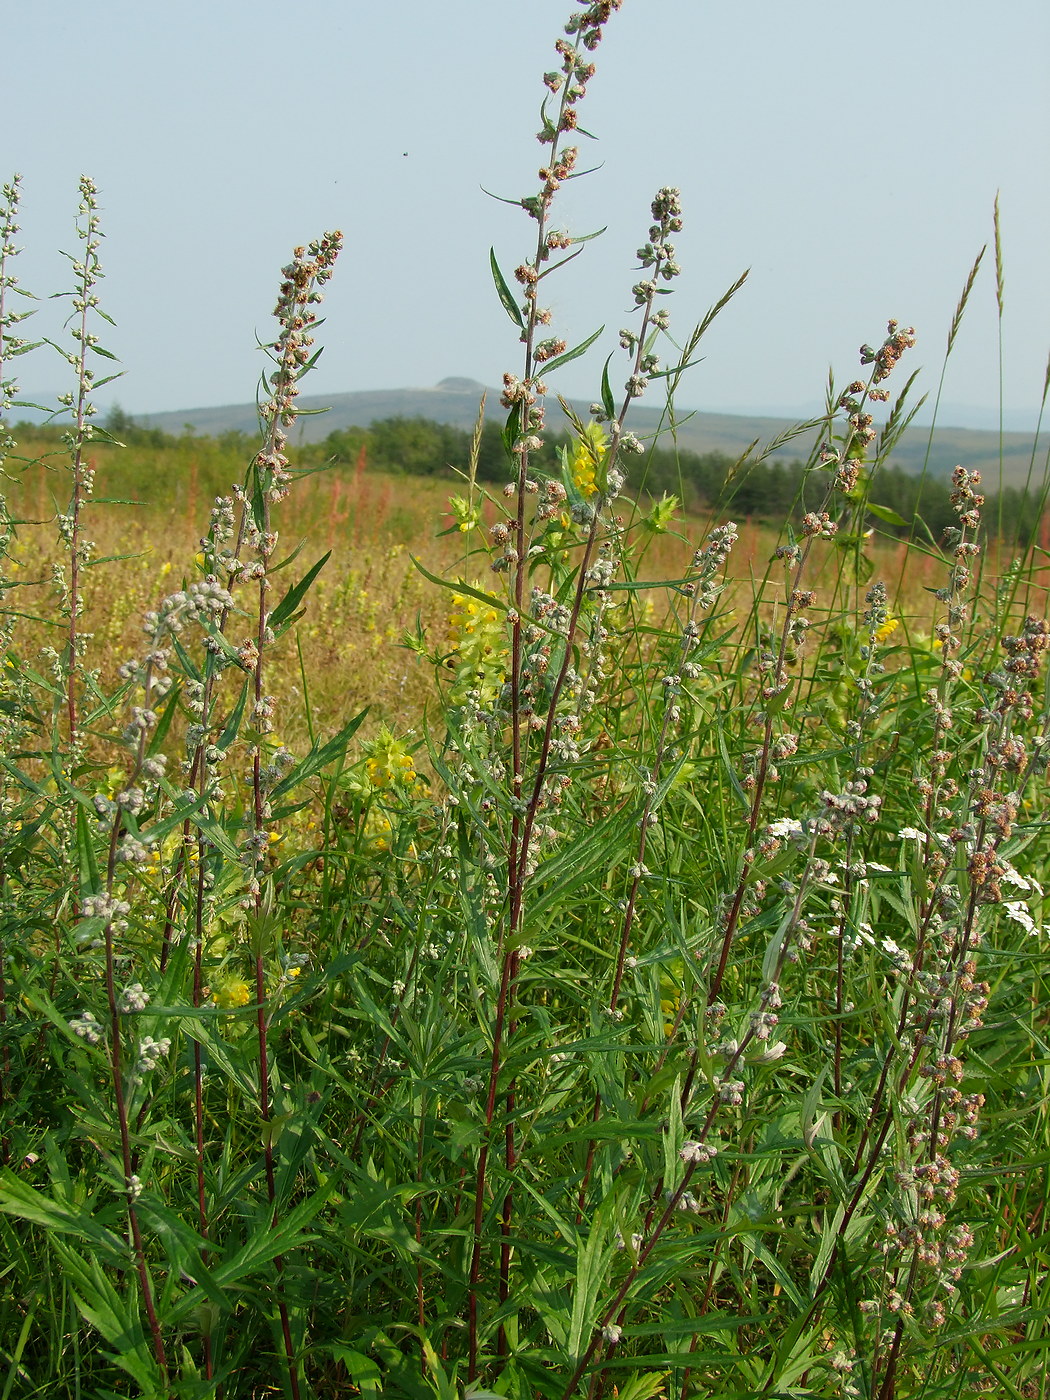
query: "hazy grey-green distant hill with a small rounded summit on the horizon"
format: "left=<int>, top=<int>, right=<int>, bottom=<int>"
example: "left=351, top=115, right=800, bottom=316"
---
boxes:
left=127, top=377, right=1039, bottom=489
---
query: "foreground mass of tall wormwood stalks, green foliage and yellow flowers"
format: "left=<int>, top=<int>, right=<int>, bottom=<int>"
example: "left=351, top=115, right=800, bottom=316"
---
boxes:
left=0, top=0, right=1050, bottom=1400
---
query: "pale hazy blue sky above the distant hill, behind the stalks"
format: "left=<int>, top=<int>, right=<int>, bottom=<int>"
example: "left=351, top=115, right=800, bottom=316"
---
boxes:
left=8, top=0, right=1050, bottom=427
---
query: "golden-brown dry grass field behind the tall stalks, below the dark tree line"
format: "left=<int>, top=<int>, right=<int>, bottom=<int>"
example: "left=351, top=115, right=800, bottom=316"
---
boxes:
left=11, top=440, right=1050, bottom=745
